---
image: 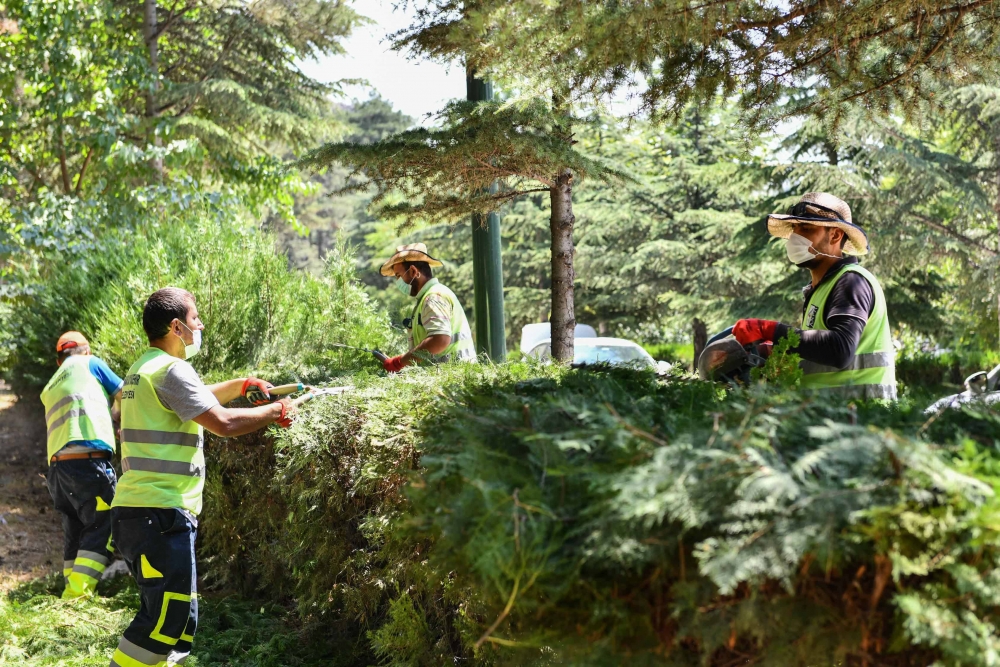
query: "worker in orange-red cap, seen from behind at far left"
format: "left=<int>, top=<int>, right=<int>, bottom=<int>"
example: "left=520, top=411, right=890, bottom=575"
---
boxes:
left=42, top=331, right=124, bottom=598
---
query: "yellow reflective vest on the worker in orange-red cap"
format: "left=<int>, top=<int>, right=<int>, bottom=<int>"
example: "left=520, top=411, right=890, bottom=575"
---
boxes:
left=42, top=355, right=115, bottom=459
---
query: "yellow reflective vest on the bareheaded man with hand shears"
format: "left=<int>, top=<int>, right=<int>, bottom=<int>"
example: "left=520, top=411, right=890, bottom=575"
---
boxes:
left=111, top=348, right=205, bottom=514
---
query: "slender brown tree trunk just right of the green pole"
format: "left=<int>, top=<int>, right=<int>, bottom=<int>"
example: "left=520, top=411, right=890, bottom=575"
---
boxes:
left=549, top=169, right=576, bottom=363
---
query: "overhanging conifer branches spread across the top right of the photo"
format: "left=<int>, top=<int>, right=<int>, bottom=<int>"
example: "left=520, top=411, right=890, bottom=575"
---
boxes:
left=395, top=0, right=1000, bottom=127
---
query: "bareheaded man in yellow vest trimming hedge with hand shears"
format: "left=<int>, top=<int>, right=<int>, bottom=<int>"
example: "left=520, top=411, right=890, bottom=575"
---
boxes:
left=110, top=287, right=294, bottom=667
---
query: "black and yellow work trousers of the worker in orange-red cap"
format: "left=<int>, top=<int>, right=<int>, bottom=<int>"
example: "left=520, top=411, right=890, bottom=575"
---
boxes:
left=45, top=458, right=118, bottom=598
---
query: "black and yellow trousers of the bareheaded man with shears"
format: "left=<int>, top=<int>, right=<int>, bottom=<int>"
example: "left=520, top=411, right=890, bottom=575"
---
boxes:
left=111, top=507, right=198, bottom=667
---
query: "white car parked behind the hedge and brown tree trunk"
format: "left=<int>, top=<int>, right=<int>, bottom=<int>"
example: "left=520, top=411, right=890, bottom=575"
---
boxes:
left=521, top=322, right=670, bottom=372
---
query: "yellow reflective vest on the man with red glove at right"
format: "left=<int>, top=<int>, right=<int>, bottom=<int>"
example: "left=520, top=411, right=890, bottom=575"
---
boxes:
left=799, top=264, right=896, bottom=400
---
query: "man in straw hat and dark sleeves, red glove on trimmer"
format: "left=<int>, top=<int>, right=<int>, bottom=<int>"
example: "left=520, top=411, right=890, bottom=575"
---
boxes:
left=733, top=192, right=896, bottom=400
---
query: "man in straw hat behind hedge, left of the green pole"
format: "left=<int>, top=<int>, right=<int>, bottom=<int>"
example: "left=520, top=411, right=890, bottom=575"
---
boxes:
left=381, top=243, right=476, bottom=373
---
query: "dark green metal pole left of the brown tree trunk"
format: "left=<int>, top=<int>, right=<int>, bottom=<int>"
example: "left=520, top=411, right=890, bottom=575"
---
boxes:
left=465, top=68, right=507, bottom=362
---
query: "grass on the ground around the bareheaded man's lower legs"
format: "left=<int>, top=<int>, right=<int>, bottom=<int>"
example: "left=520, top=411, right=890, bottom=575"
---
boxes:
left=0, top=574, right=357, bottom=667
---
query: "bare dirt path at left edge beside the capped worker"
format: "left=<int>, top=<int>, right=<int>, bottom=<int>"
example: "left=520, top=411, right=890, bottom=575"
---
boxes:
left=0, top=383, right=62, bottom=590
